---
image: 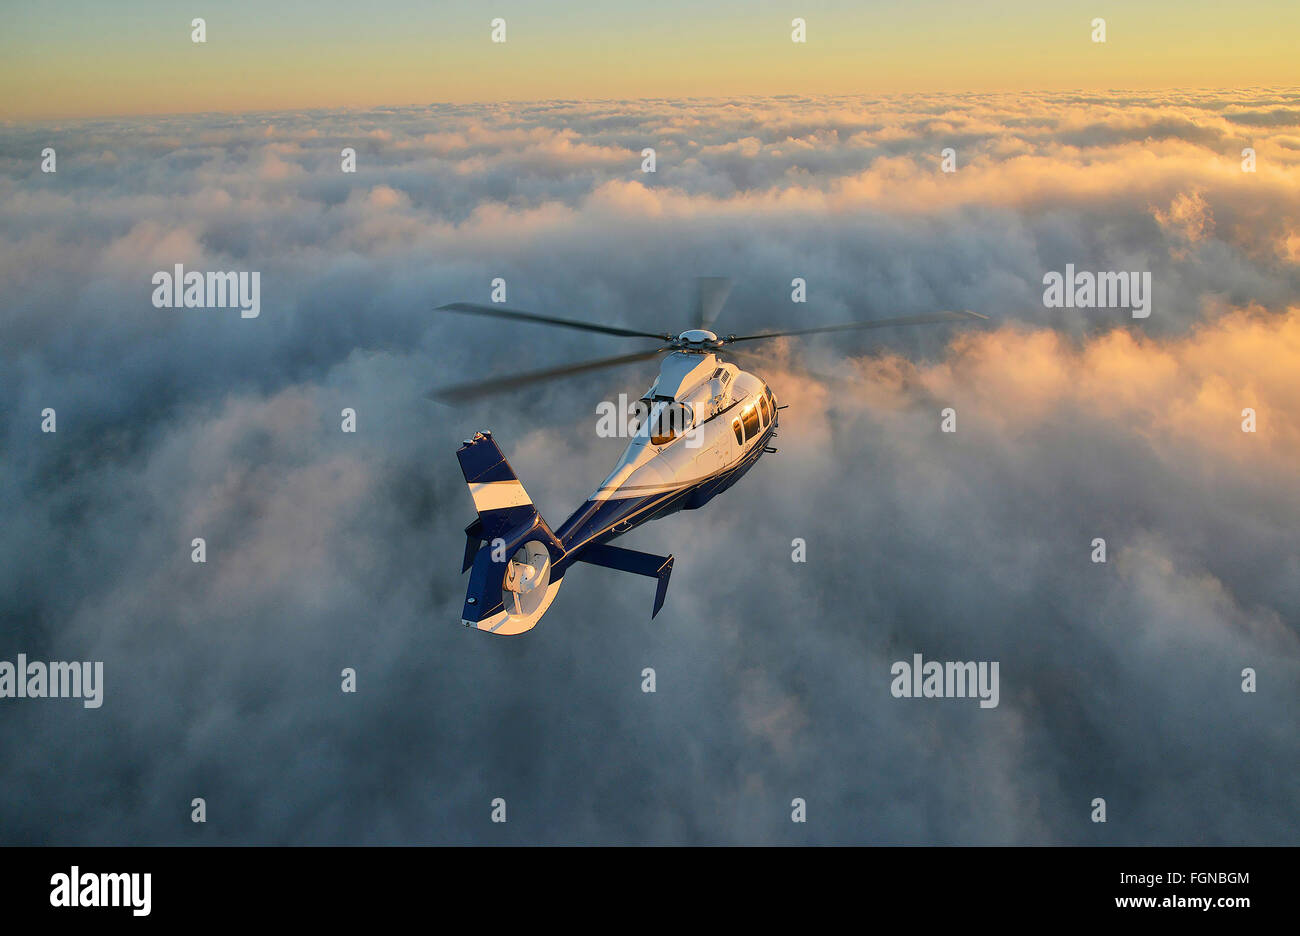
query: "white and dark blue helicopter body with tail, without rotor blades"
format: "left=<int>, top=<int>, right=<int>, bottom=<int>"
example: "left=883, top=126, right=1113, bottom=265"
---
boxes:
left=456, top=348, right=777, bottom=634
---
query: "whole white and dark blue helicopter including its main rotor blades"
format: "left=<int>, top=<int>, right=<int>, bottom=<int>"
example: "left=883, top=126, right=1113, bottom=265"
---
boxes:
left=429, top=277, right=988, bottom=636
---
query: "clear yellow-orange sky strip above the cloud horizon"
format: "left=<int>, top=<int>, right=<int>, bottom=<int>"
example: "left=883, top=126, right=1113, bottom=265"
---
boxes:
left=0, top=0, right=1300, bottom=121
